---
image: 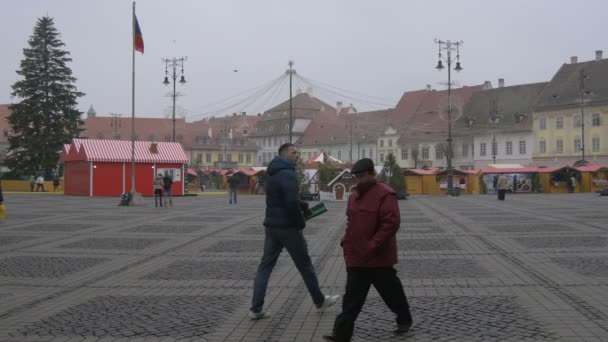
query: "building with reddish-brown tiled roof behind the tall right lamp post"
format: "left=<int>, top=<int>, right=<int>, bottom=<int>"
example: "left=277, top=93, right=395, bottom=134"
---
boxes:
left=392, top=82, right=491, bottom=167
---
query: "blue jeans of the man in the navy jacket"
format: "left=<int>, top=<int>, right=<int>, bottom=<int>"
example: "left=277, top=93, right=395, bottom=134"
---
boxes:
left=251, top=227, right=325, bottom=312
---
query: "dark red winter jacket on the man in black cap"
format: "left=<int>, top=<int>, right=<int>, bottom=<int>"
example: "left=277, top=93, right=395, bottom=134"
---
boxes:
left=342, top=183, right=401, bottom=267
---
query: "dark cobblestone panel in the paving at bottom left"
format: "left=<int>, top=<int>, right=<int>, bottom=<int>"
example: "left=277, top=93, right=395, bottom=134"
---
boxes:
left=19, top=296, right=239, bottom=339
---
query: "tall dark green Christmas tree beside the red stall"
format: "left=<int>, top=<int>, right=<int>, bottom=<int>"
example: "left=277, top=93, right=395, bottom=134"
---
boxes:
left=7, top=17, right=84, bottom=177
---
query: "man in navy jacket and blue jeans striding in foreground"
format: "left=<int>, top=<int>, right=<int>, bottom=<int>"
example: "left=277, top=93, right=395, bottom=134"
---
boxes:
left=249, top=144, right=340, bottom=319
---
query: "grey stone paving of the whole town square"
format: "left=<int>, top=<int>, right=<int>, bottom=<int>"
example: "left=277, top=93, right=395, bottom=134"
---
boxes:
left=0, top=194, right=608, bottom=342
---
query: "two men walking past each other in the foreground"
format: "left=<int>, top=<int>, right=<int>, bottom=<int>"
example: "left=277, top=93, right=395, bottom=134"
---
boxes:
left=248, top=144, right=413, bottom=342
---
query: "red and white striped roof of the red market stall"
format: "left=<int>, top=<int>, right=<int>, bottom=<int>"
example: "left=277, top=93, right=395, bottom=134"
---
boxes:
left=61, top=139, right=188, bottom=164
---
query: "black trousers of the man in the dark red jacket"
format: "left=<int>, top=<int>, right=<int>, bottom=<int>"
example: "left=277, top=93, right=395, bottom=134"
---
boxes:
left=333, top=267, right=412, bottom=342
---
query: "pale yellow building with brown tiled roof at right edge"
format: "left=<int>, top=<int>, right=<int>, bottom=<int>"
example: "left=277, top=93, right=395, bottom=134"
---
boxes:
left=533, top=51, right=608, bottom=166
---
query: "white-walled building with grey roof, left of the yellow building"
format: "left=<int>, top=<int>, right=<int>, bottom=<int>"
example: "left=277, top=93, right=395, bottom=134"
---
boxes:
left=454, top=79, right=547, bottom=169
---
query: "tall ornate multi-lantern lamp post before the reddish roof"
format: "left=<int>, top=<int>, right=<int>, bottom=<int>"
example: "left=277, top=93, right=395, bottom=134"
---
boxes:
left=435, top=39, right=463, bottom=195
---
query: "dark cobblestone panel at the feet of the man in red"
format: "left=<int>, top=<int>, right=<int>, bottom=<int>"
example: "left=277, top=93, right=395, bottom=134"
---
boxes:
left=355, top=296, right=555, bottom=341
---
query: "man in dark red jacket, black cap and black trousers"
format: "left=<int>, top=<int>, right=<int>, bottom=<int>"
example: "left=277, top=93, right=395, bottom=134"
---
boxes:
left=323, top=158, right=413, bottom=342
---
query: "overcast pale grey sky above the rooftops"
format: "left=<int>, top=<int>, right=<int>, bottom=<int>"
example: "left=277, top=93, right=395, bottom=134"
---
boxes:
left=0, top=0, right=608, bottom=120
